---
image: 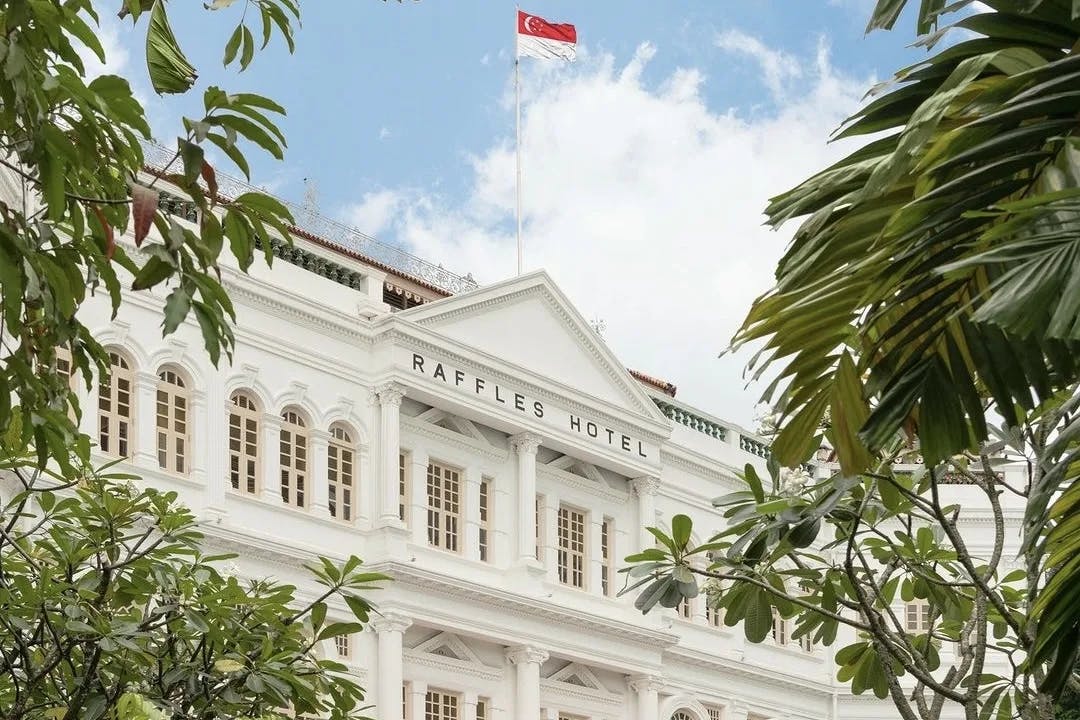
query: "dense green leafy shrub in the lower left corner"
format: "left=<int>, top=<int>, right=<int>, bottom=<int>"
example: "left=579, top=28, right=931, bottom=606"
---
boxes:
left=0, top=458, right=384, bottom=720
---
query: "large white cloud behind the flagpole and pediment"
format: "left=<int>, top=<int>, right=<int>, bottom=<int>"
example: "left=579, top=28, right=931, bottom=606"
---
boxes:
left=362, top=33, right=870, bottom=424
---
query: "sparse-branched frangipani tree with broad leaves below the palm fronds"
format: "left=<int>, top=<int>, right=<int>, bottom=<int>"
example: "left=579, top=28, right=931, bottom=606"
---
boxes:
left=623, top=427, right=1051, bottom=720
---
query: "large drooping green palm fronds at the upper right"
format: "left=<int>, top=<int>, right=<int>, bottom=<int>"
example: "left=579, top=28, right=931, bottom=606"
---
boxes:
left=735, top=0, right=1080, bottom=692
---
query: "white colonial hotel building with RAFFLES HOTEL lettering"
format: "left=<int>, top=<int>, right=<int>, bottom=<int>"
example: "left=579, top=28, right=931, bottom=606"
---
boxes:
left=4, top=162, right=1010, bottom=720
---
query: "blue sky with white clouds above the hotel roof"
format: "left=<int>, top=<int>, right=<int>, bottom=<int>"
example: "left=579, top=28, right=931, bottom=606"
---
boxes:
left=92, top=0, right=950, bottom=426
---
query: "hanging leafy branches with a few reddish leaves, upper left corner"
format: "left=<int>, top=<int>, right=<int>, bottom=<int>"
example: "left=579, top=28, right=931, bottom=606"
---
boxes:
left=0, top=0, right=299, bottom=473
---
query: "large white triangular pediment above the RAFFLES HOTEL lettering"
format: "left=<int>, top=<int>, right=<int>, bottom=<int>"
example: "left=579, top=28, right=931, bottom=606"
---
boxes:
left=397, top=271, right=663, bottom=421
